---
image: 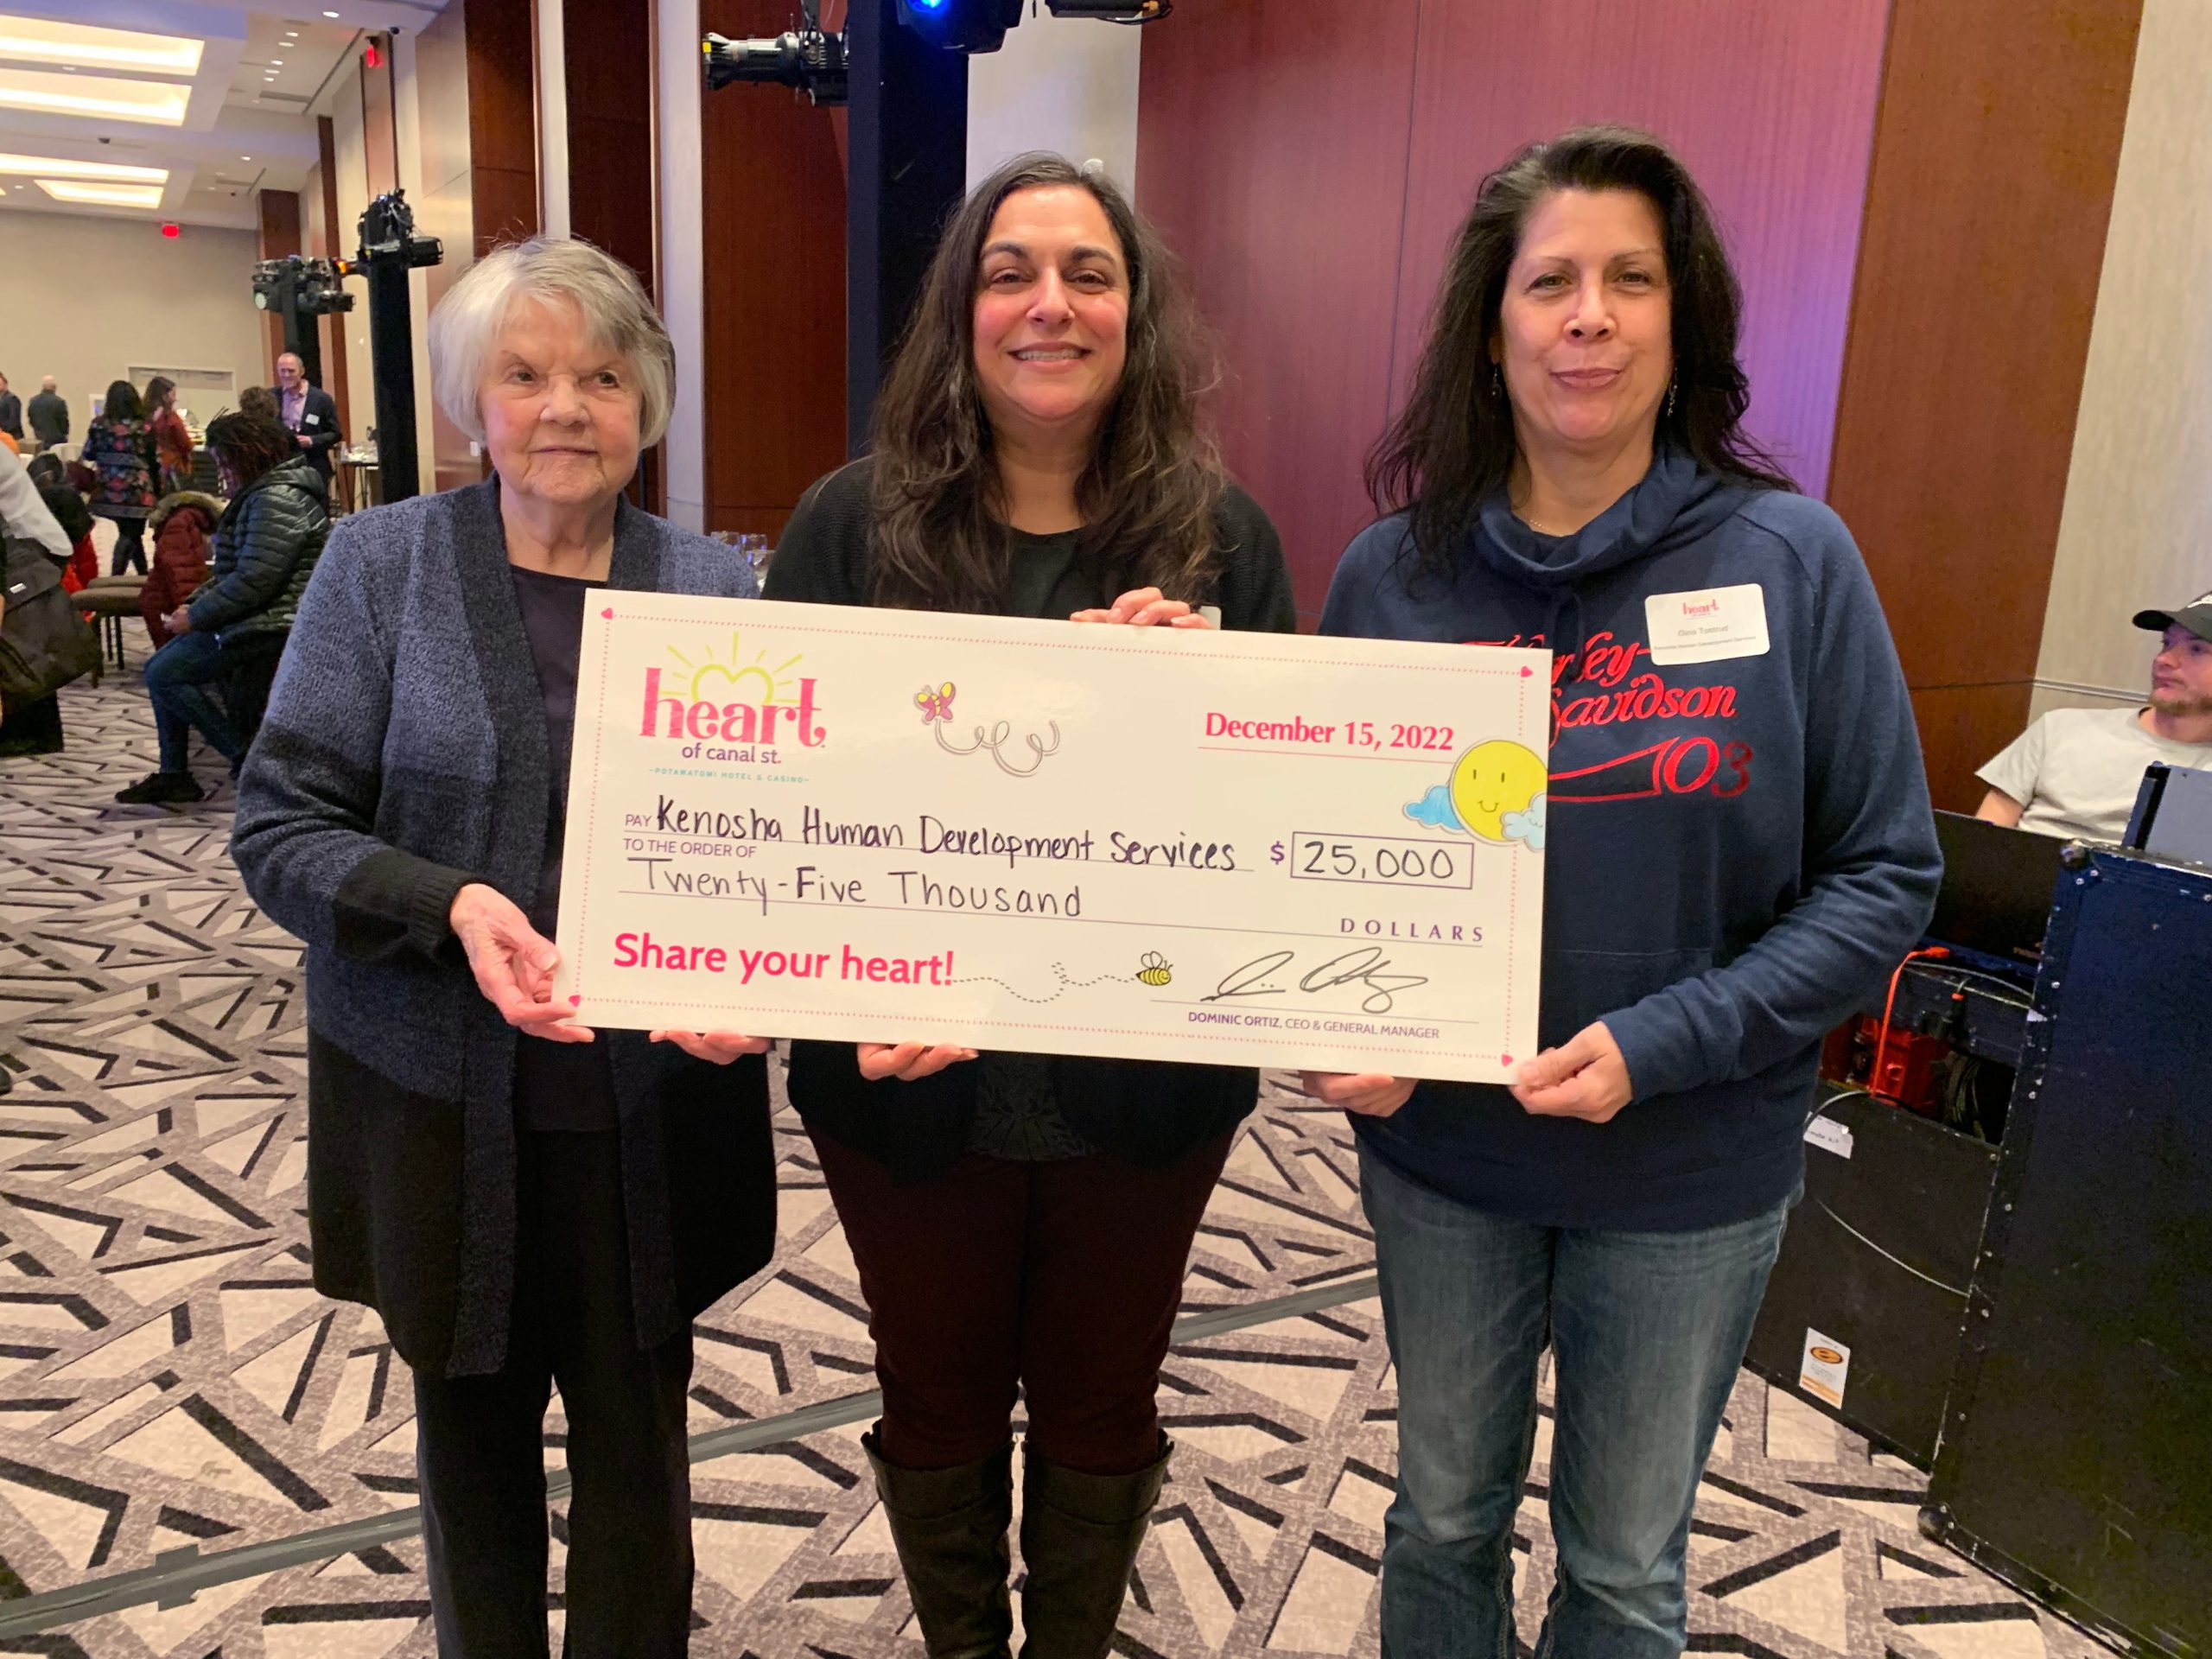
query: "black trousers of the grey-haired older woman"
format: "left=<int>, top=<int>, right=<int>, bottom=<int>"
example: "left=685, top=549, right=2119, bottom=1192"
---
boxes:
left=414, top=1130, right=692, bottom=1659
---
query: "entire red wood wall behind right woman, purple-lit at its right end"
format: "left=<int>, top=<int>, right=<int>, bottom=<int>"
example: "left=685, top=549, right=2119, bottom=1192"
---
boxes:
left=1137, top=0, right=1889, bottom=613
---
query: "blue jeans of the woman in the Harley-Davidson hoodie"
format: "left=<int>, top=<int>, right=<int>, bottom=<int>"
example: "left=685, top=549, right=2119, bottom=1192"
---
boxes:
left=1360, top=1148, right=1787, bottom=1659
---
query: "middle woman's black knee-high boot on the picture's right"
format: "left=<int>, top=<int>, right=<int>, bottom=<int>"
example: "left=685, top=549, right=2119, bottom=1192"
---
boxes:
left=1022, top=1435, right=1174, bottom=1659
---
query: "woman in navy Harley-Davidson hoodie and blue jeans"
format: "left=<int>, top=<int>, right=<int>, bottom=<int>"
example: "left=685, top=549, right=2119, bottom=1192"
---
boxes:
left=1307, top=128, right=1940, bottom=1659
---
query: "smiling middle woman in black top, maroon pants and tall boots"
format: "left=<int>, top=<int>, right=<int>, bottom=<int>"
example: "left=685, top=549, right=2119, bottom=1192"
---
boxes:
left=767, top=155, right=1296, bottom=1659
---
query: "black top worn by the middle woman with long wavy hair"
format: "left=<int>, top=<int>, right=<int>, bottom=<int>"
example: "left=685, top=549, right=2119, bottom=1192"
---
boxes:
left=763, top=460, right=1299, bottom=1181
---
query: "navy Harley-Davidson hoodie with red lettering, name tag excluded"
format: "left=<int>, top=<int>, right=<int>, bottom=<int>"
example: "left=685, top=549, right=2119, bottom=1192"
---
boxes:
left=1320, top=451, right=1942, bottom=1232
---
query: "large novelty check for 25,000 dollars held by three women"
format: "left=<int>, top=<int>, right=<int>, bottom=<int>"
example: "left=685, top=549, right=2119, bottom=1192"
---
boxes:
left=557, top=593, right=1551, bottom=1082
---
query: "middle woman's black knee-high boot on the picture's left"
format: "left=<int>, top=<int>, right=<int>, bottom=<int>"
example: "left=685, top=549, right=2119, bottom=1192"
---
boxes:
left=861, top=1431, right=1027, bottom=1659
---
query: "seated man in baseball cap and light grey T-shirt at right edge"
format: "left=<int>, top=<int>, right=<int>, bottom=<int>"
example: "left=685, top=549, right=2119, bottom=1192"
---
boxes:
left=1975, top=593, right=2212, bottom=841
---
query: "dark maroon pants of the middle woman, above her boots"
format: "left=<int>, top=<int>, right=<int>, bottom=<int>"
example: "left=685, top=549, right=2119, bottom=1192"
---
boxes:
left=814, top=1130, right=1236, bottom=1476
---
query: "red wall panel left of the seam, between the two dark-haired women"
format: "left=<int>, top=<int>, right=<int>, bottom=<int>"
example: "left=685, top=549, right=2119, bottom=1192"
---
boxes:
left=1137, top=0, right=1421, bottom=626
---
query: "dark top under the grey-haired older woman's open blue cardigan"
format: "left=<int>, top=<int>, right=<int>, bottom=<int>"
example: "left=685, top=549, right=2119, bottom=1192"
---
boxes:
left=511, top=564, right=617, bottom=1130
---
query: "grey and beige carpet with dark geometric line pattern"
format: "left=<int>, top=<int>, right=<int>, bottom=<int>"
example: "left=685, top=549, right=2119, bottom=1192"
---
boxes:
left=0, top=635, right=2097, bottom=1659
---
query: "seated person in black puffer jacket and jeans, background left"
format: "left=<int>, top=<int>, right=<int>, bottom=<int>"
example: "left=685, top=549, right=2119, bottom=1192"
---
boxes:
left=115, top=414, right=329, bottom=805
